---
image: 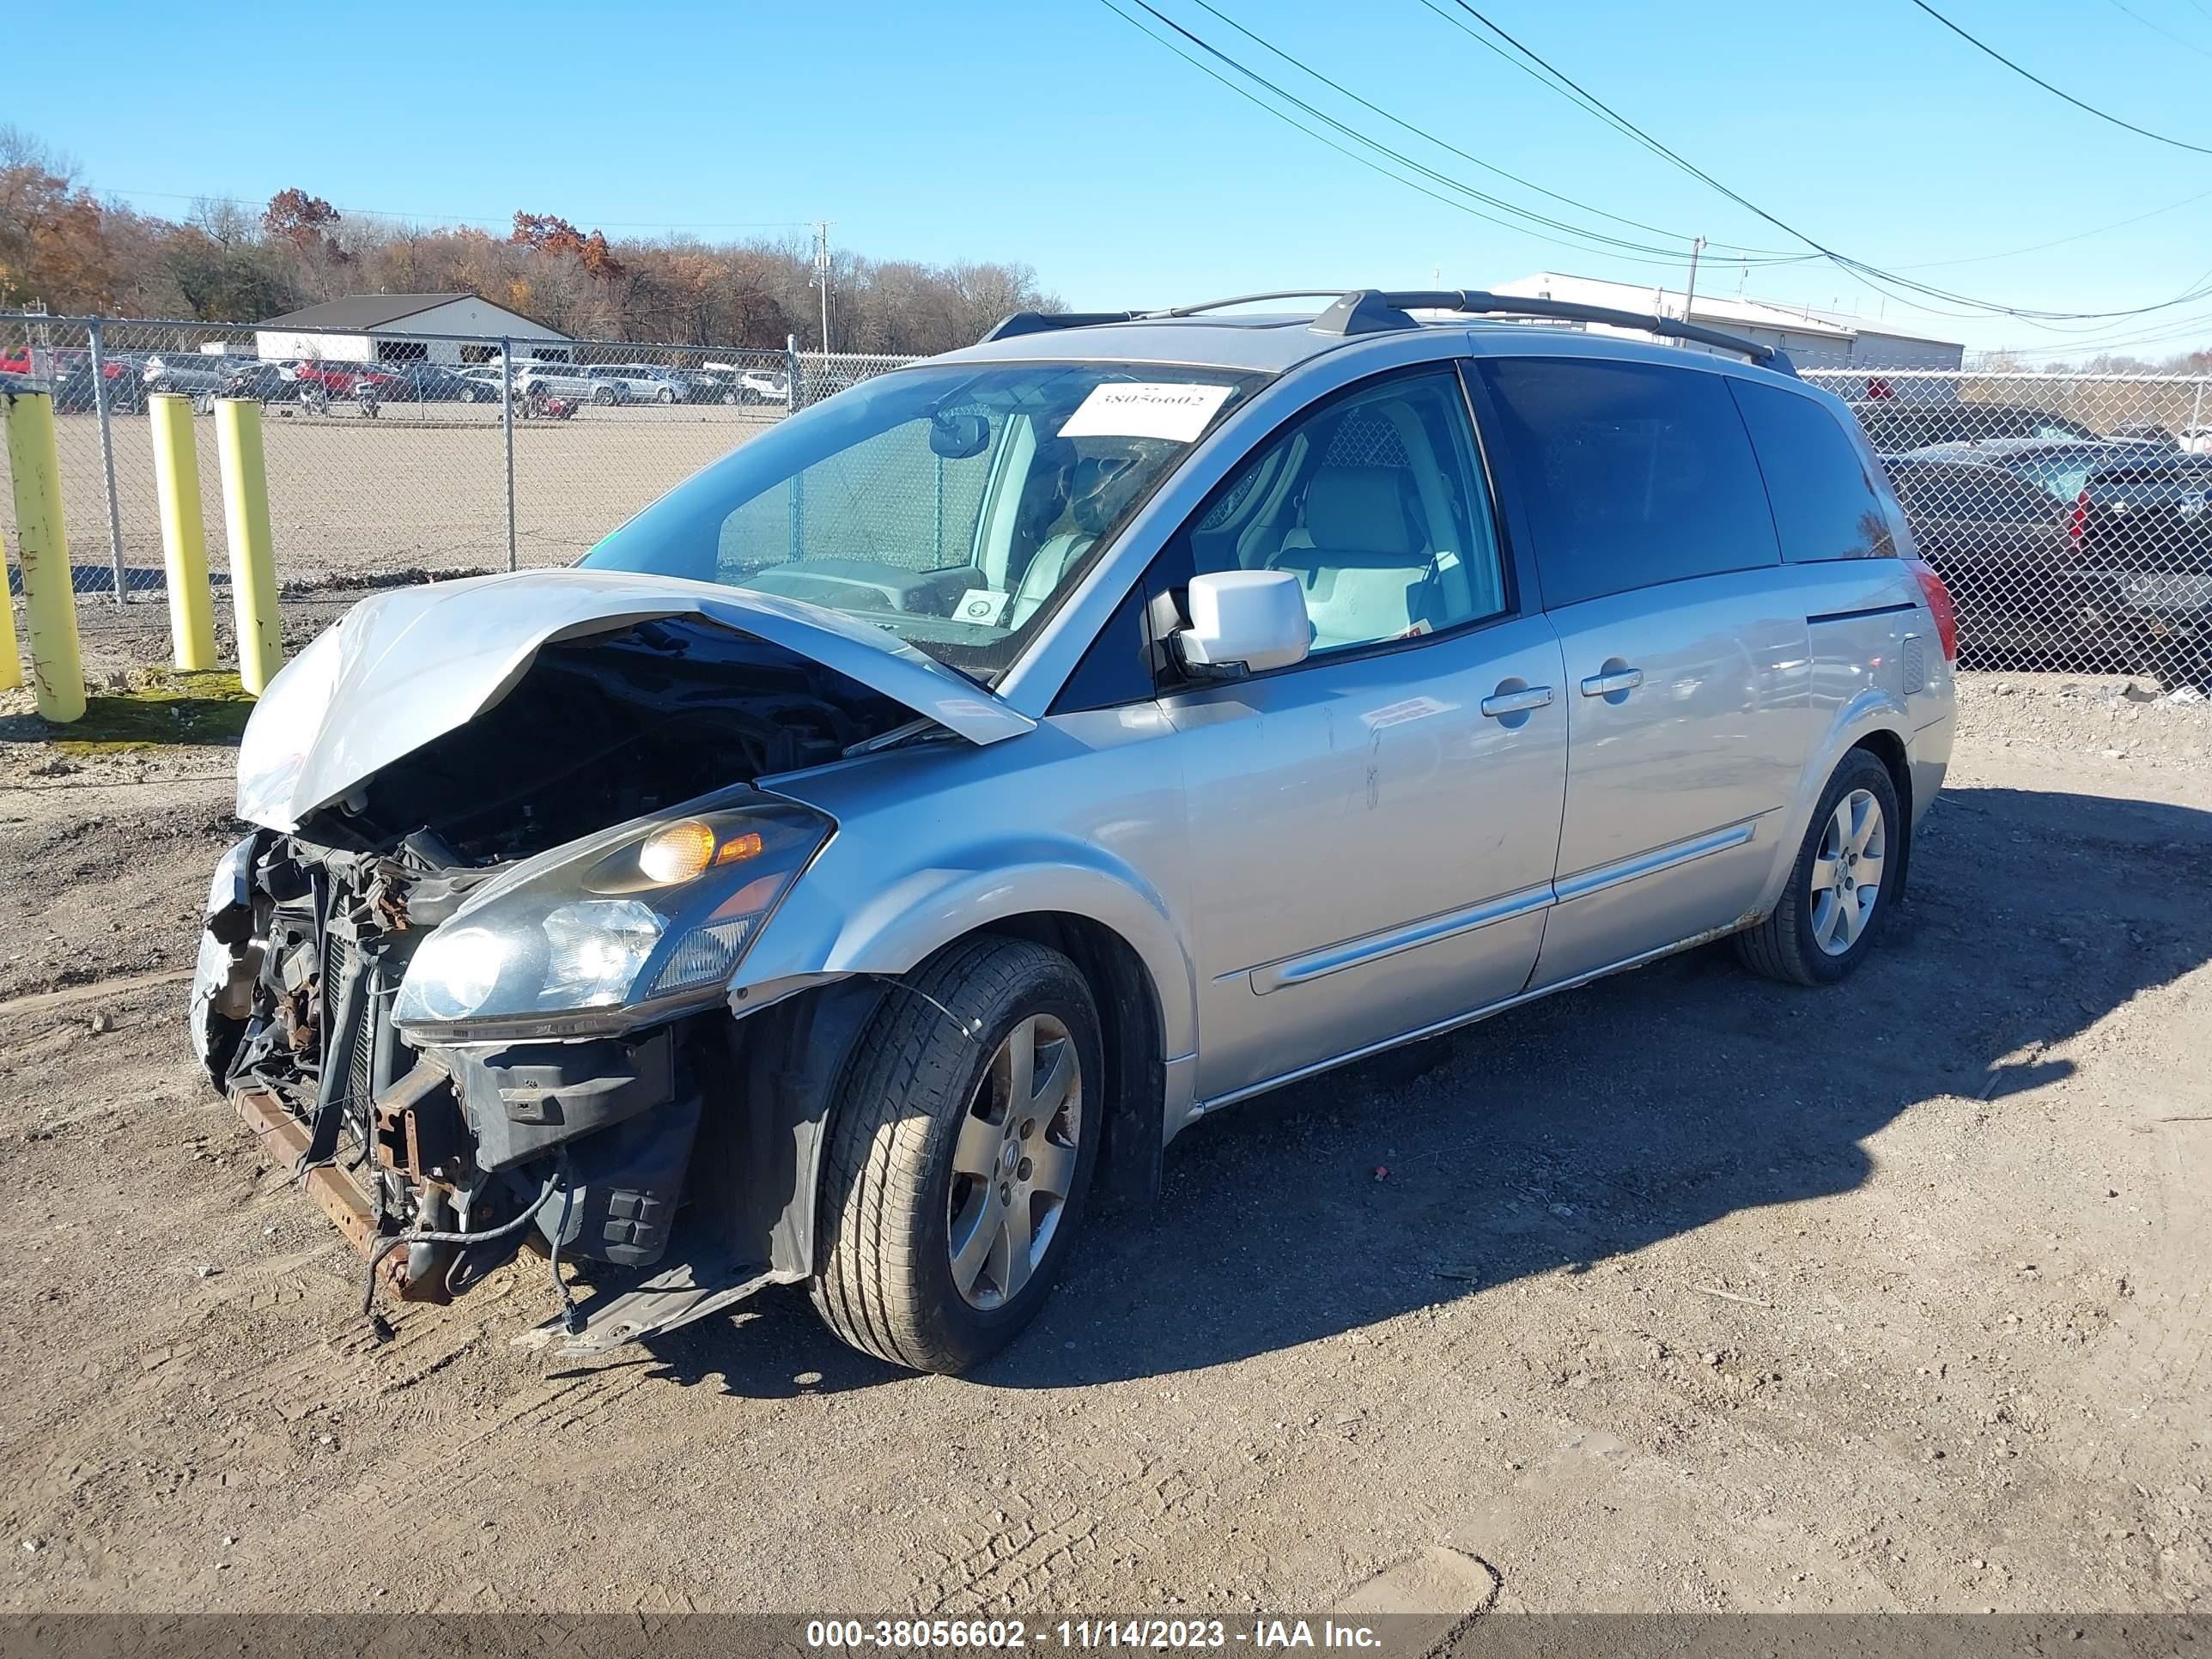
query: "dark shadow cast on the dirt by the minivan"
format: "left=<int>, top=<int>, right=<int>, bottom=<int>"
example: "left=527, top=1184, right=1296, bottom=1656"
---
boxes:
left=650, top=790, right=2212, bottom=1395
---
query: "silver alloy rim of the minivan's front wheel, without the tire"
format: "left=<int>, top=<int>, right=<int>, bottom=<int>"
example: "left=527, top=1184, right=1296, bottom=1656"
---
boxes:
left=947, top=1013, right=1084, bottom=1310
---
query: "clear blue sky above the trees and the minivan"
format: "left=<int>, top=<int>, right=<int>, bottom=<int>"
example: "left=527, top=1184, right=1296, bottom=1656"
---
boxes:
left=13, top=0, right=2212, bottom=354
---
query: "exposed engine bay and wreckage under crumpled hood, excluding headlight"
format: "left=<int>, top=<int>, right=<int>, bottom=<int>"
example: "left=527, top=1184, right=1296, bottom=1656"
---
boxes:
left=192, top=617, right=938, bottom=1345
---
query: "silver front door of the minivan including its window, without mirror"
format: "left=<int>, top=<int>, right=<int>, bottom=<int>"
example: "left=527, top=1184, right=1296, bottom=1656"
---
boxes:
left=1161, top=365, right=1566, bottom=1103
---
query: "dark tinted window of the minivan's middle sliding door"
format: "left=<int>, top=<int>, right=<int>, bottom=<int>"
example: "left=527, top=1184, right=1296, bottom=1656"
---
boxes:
left=1482, top=358, right=1781, bottom=608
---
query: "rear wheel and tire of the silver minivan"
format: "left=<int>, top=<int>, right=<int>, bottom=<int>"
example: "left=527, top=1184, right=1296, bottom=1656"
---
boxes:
left=1736, top=750, right=1905, bottom=984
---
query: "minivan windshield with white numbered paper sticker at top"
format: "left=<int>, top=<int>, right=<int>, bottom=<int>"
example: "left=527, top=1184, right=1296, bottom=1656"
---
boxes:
left=584, top=362, right=1261, bottom=679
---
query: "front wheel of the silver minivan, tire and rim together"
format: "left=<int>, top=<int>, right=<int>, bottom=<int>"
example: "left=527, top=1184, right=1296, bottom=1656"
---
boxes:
left=810, top=938, right=1106, bottom=1374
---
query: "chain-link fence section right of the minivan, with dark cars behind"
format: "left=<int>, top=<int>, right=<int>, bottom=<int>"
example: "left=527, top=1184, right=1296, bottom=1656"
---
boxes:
left=1805, top=369, right=2212, bottom=688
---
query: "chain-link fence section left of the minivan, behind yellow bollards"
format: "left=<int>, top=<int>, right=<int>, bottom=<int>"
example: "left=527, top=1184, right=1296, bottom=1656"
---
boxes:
left=0, top=312, right=909, bottom=606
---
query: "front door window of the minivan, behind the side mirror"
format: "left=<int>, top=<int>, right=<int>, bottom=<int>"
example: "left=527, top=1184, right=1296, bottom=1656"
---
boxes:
left=1182, top=368, right=1506, bottom=654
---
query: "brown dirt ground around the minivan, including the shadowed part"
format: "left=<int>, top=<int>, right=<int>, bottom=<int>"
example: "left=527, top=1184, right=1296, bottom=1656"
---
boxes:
left=0, top=654, right=2212, bottom=1617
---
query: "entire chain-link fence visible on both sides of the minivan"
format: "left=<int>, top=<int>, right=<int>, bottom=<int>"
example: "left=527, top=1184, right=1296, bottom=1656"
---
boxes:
left=0, top=312, right=2212, bottom=686
